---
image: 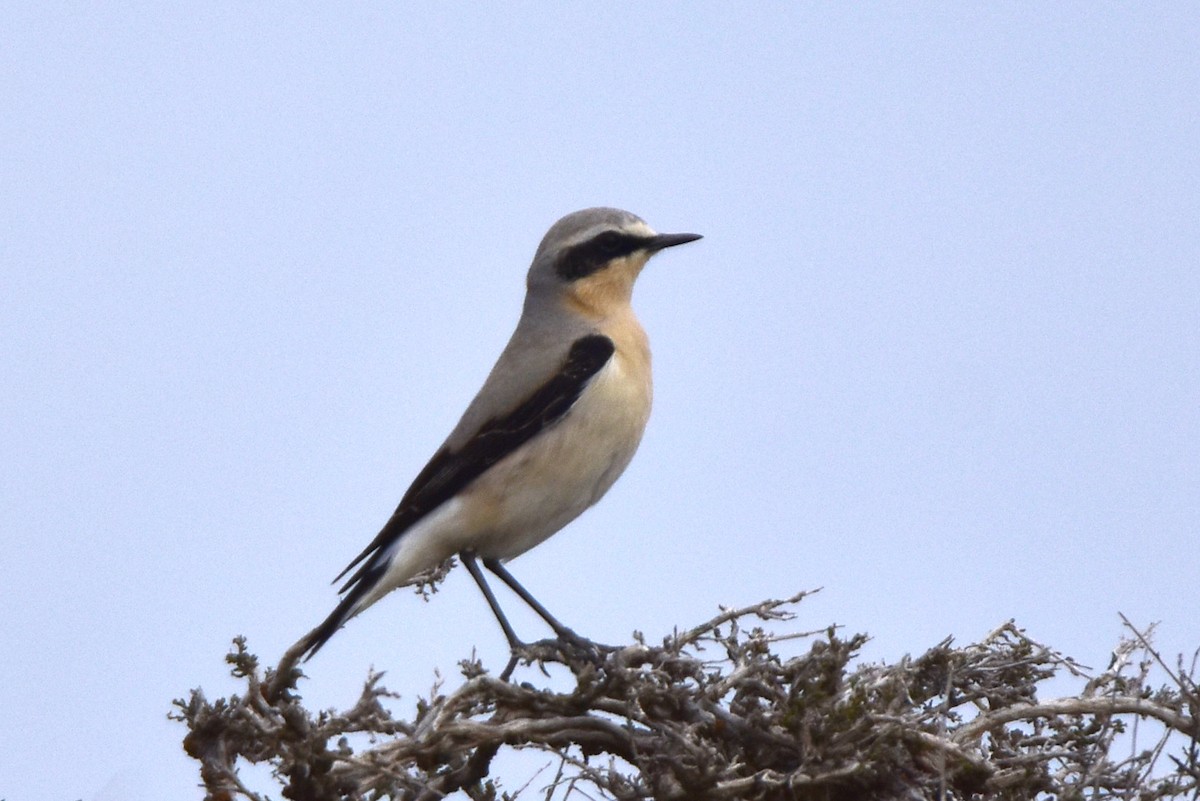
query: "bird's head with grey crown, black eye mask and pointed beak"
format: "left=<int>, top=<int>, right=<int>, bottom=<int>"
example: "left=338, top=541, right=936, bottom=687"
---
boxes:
left=527, top=207, right=700, bottom=317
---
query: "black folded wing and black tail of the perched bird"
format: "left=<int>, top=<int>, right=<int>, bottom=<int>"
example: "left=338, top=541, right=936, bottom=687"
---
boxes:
left=298, top=335, right=616, bottom=658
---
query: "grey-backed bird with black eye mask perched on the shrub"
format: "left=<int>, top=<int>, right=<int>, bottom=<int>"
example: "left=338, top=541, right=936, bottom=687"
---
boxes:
left=289, top=207, right=701, bottom=661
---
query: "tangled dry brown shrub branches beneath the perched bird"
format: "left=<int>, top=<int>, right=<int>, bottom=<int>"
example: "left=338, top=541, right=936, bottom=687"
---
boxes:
left=173, top=592, right=1200, bottom=801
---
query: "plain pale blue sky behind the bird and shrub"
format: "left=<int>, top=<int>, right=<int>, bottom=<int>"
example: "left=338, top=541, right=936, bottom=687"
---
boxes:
left=0, top=2, right=1200, bottom=801
